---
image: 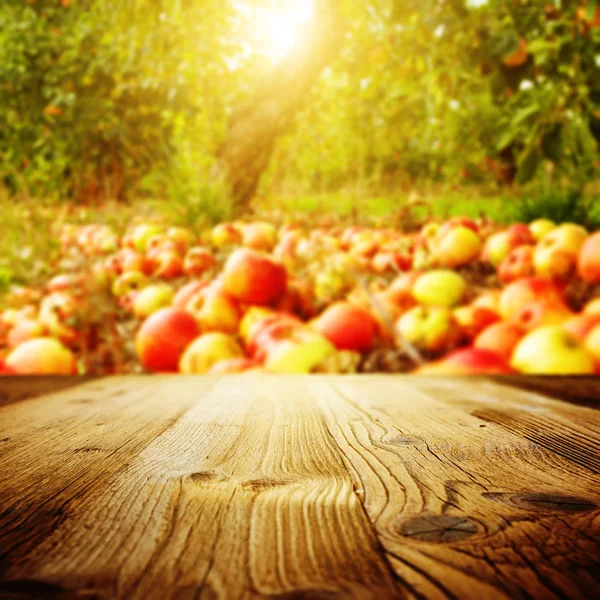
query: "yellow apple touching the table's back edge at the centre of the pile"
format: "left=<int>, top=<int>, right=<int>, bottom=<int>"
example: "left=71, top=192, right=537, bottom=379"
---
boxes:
left=265, top=328, right=336, bottom=373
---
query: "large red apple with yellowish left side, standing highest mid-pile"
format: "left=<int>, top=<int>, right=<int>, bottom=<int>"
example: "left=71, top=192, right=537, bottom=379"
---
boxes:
left=223, top=248, right=287, bottom=305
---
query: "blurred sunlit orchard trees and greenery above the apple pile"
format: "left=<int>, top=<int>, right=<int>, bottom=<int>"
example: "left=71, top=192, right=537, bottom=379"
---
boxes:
left=0, top=0, right=600, bottom=220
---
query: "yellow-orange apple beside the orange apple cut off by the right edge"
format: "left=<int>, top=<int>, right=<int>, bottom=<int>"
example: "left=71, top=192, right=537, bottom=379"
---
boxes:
left=533, top=223, right=588, bottom=279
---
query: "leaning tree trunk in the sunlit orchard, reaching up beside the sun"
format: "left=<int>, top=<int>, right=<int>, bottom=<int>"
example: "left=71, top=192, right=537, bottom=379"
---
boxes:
left=218, top=0, right=345, bottom=209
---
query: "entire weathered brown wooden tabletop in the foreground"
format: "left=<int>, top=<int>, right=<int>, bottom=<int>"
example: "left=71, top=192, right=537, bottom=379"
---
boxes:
left=0, top=374, right=600, bottom=600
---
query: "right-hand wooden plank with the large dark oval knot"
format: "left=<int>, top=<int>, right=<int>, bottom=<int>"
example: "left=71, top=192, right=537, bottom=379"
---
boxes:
left=312, top=377, right=600, bottom=600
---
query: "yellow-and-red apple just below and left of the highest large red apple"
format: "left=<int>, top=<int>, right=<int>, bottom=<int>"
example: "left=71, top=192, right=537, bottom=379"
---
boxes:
left=185, top=282, right=241, bottom=333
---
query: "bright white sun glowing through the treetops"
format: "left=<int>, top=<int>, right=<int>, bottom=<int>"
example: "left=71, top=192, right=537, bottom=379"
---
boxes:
left=252, top=0, right=313, bottom=62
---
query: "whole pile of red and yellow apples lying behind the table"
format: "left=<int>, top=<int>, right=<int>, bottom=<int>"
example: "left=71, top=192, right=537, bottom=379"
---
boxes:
left=0, top=217, right=600, bottom=374
